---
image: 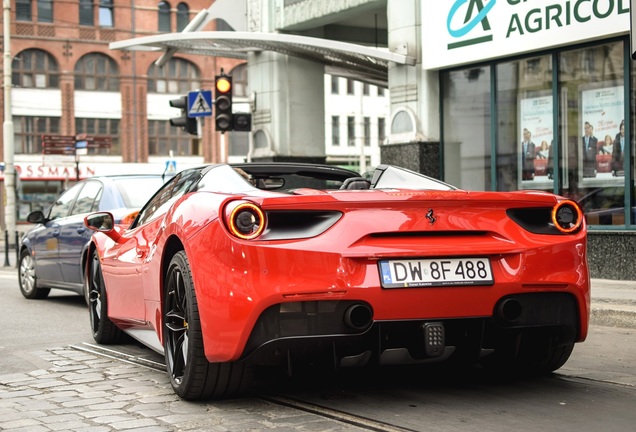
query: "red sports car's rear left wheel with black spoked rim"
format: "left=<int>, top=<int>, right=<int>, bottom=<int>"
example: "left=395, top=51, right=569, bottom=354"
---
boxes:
left=163, top=251, right=253, bottom=400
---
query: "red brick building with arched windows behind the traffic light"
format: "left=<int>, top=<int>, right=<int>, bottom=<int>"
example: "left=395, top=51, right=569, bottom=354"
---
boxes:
left=0, top=0, right=246, bottom=227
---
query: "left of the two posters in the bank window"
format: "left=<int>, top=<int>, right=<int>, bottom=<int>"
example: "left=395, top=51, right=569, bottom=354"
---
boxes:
left=518, top=92, right=554, bottom=188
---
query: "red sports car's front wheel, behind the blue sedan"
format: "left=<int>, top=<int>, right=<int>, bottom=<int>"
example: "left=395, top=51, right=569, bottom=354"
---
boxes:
left=86, top=251, right=121, bottom=345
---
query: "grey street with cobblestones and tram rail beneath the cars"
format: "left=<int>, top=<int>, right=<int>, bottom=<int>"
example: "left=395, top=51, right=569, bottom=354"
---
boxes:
left=0, top=272, right=636, bottom=432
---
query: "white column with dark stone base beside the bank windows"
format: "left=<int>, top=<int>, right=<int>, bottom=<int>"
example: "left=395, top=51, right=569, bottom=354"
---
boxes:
left=380, top=0, right=442, bottom=178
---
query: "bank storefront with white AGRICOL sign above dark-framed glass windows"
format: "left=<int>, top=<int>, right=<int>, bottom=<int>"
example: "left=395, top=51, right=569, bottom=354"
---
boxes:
left=422, top=0, right=636, bottom=279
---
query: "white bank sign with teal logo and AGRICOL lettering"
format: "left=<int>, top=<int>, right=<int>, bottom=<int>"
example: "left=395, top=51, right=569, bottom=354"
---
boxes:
left=421, top=0, right=630, bottom=69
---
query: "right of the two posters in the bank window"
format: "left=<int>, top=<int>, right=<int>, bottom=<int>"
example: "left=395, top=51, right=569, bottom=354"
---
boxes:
left=578, top=84, right=625, bottom=183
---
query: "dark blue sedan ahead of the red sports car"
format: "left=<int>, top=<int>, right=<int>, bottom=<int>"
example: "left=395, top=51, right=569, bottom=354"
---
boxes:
left=18, top=175, right=164, bottom=299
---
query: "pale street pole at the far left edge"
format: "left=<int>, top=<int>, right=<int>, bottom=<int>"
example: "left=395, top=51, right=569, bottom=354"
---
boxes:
left=2, top=0, right=16, bottom=236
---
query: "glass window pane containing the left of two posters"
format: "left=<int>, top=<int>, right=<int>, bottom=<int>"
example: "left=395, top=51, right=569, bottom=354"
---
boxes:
left=495, top=56, right=554, bottom=191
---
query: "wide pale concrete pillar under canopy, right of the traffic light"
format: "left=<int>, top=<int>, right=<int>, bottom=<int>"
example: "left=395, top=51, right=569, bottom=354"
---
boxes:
left=248, top=52, right=326, bottom=163
